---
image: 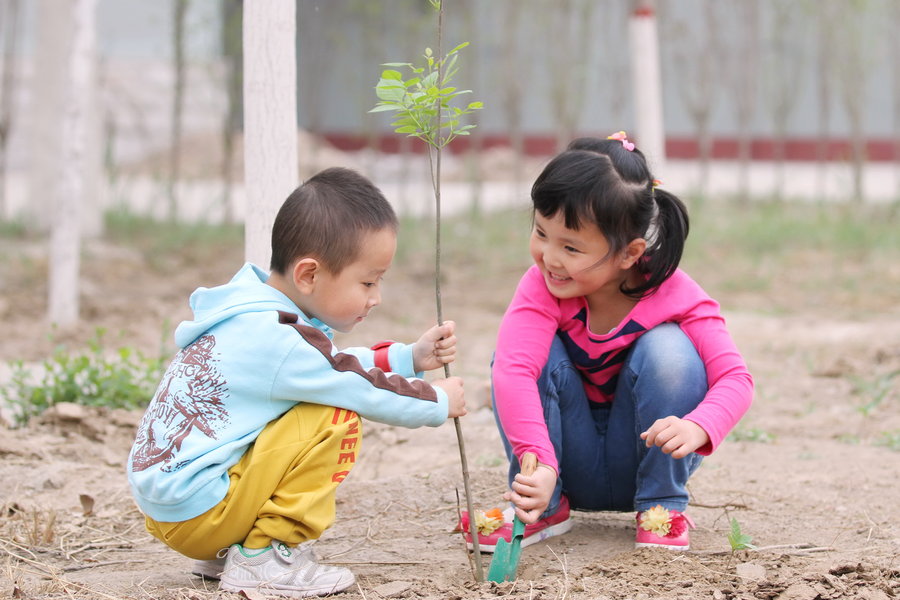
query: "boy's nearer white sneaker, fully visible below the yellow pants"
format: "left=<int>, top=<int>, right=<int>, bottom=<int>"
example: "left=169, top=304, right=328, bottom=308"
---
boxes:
left=219, top=540, right=356, bottom=598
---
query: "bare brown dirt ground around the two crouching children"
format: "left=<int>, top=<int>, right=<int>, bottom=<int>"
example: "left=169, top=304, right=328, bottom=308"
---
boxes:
left=0, top=195, right=900, bottom=600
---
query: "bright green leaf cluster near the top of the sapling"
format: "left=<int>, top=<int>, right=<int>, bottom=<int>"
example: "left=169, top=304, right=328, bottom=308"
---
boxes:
left=369, top=42, right=484, bottom=148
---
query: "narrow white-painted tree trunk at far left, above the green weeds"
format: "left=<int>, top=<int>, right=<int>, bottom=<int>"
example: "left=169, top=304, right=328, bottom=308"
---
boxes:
left=48, top=0, right=96, bottom=328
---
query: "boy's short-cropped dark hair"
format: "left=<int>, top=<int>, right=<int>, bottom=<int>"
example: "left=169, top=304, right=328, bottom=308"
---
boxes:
left=269, top=167, right=398, bottom=275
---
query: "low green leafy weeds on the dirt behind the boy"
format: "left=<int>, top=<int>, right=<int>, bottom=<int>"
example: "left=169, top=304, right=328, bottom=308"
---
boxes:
left=0, top=328, right=165, bottom=425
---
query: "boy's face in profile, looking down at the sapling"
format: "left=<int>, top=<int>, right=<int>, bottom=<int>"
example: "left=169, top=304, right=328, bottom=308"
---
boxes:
left=306, top=228, right=397, bottom=333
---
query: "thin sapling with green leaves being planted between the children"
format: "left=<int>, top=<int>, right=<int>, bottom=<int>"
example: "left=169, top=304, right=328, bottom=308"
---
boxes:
left=369, top=0, right=484, bottom=582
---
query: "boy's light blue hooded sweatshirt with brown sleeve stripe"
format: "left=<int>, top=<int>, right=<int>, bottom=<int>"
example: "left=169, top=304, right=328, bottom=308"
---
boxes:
left=128, top=263, right=448, bottom=522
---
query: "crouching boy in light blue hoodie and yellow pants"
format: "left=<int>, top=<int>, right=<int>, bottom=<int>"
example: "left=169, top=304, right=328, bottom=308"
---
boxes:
left=128, top=168, right=466, bottom=597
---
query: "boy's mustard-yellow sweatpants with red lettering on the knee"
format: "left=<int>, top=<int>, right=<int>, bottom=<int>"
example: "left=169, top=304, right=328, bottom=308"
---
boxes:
left=146, top=403, right=362, bottom=560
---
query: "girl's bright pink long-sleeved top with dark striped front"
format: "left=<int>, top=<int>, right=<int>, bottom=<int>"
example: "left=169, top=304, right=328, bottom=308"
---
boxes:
left=492, top=266, right=753, bottom=469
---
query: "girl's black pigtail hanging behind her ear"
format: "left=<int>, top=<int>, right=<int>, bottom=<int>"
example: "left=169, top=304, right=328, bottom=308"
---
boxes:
left=623, top=187, right=690, bottom=296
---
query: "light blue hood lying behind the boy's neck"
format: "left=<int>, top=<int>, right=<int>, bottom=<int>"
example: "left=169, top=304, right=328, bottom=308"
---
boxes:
left=175, top=263, right=333, bottom=348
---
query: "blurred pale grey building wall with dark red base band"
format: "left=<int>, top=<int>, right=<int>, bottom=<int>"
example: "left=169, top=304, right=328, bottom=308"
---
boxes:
left=2, top=0, right=900, bottom=204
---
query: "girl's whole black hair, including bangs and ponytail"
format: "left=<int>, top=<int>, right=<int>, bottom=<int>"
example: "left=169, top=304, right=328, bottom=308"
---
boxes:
left=531, top=138, right=689, bottom=298
